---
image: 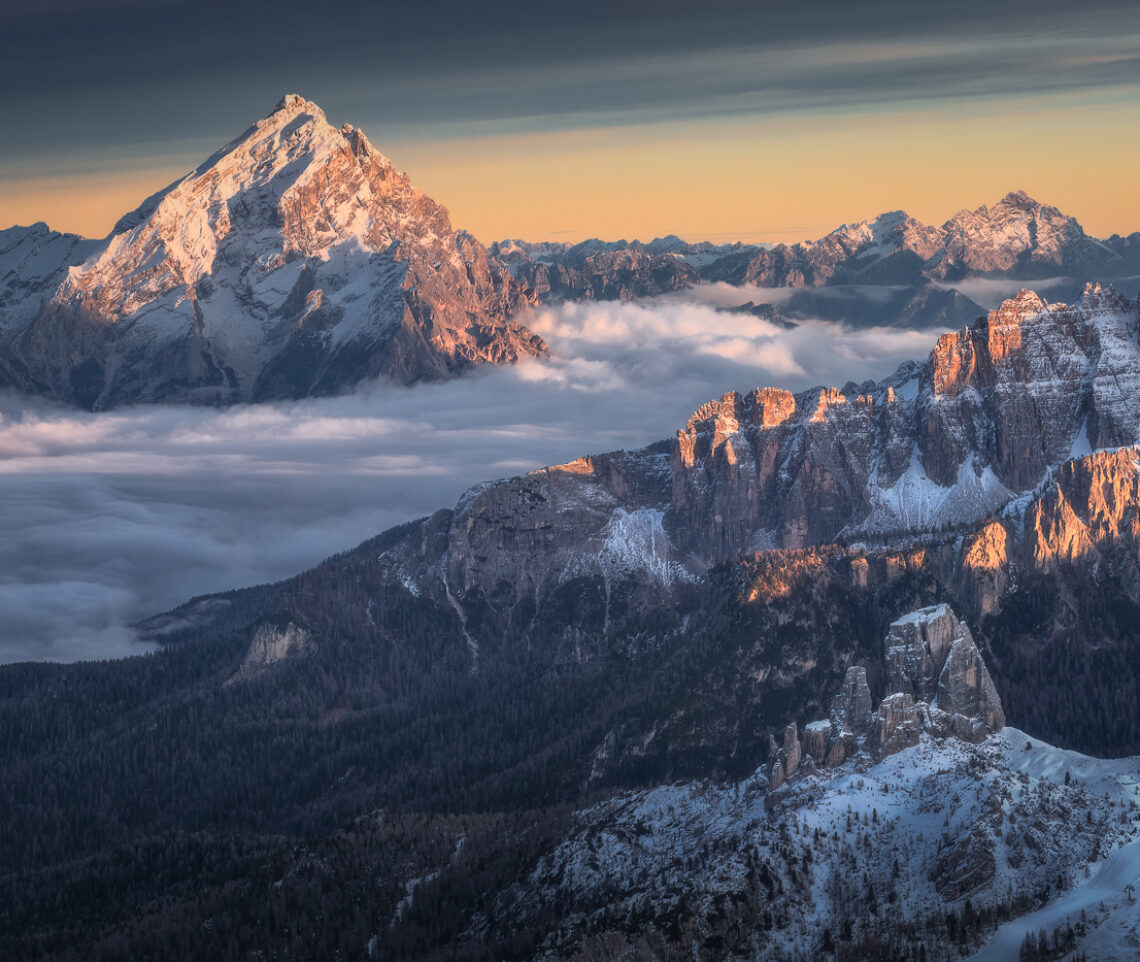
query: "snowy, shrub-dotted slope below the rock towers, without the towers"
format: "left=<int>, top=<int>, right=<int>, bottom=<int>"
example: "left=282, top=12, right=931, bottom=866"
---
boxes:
left=496, top=728, right=1140, bottom=962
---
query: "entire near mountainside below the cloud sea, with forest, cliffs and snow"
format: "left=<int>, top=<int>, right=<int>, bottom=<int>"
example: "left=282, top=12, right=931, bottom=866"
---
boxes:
left=0, top=285, right=1140, bottom=962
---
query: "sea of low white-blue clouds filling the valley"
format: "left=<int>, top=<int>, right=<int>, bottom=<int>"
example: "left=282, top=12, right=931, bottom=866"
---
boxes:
left=0, top=290, right=936, bottom=662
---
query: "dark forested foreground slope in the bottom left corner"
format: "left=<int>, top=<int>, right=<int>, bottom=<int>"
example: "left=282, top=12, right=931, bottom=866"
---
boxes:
left=0, top=809, right=568, bottom=962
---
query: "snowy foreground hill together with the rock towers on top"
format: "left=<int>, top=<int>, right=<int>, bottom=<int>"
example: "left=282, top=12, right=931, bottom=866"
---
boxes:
left=470, top=605, right=1140, bottom=960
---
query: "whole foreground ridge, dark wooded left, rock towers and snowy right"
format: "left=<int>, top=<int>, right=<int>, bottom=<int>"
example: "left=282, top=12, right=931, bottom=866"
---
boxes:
left=0, top=605, right=1140, bottom=962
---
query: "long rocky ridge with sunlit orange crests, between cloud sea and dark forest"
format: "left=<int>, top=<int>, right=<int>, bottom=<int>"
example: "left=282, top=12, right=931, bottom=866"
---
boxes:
left=326, top=281, right=1140, bottom=644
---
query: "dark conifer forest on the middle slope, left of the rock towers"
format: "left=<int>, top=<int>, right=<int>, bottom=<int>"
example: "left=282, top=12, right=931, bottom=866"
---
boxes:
left=0, top=551, right=930, bottom=871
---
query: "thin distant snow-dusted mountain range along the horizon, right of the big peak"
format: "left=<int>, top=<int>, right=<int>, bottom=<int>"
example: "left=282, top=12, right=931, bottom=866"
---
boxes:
left=503, top=191, right=1140, bottom=300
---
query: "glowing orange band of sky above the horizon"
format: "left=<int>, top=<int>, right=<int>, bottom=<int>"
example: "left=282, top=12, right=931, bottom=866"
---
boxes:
left=0, top=91, right=1140, bottom=242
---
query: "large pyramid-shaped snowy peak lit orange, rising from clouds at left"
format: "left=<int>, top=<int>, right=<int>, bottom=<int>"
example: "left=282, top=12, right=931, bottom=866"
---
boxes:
left=0, top=95, right=545, bottom=409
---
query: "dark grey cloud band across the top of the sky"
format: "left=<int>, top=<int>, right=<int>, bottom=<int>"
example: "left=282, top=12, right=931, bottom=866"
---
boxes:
left=0, top=0, right=1140, bottom=171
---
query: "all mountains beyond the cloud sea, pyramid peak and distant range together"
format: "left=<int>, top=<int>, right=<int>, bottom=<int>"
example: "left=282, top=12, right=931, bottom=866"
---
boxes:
left=0, top=95, right=1140, bottom=409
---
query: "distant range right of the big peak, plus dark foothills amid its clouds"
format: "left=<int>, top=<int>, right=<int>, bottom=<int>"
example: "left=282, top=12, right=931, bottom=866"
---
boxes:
left=501, top=191, right=1140, bottom=327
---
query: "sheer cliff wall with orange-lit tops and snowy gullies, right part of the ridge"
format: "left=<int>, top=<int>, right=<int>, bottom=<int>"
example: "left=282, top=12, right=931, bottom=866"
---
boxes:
left=671, top=287, right=1140, bottom=561
